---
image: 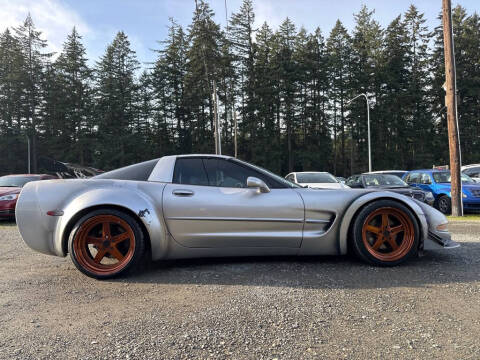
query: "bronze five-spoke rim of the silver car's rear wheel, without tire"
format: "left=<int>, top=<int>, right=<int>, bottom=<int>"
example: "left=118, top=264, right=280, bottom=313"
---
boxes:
left=72, top=214, right=135, bottom=277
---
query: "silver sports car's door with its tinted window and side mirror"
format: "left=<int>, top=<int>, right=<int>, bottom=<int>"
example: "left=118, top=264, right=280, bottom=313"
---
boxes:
left=163, top=157, right=304, bottom=248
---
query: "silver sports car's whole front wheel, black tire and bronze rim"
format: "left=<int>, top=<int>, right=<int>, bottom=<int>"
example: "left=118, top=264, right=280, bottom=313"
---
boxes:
left=350, top=200, right=420, bottom=266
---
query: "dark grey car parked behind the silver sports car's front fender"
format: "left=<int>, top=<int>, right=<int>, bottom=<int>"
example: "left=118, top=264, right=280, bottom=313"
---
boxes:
left=346, top=174, right=435, bottom=206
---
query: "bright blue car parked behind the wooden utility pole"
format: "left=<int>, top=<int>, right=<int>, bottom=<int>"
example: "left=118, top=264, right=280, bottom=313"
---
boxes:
left=403, top=170, right=480, bottom=214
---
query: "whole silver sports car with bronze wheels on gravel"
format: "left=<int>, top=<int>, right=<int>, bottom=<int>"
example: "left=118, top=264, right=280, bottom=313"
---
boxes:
left=16, top=155, right=458, bottom=279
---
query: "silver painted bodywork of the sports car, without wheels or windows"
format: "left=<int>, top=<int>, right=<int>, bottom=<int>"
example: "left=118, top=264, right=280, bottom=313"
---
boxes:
left=16, top=155, right=455, bottom=260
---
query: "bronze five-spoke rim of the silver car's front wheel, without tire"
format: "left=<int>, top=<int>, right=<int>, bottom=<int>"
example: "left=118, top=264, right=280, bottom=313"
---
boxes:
left=362, top=207, right=415, bottom=262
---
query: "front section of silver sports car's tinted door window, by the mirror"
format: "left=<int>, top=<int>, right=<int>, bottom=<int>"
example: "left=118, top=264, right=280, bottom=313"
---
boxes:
left=204, top=158, right=270, bottom=188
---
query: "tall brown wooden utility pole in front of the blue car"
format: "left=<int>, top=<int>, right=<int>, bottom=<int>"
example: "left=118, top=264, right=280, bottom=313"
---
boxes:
left=442, top=0, right=463, bottom=216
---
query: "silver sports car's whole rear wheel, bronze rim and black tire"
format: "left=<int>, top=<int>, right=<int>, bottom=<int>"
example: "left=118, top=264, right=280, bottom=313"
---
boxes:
left=68, top=209, right=145, bottom=279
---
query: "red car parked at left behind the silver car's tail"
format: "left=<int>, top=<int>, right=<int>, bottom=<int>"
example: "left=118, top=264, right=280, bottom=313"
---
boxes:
left=0, top=174, right=57, bottom=219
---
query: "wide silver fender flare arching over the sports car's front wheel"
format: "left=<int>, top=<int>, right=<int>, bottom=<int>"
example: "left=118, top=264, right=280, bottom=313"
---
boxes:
left=338, top=191, right=428, bottom=255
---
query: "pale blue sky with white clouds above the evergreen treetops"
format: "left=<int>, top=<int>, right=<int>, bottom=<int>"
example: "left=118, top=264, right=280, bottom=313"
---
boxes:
left=0, top=0, right=480, bottom=64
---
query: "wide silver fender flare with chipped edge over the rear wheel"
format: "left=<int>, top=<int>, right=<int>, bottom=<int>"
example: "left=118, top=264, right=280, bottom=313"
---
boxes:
left=54, top=187, right=168, bottom=257
